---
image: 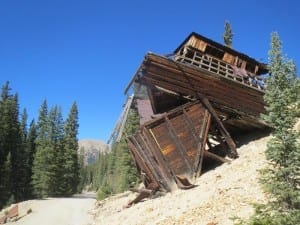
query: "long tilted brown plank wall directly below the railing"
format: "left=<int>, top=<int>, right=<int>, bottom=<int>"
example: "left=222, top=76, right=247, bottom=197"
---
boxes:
left=140, top=53, right=265, bottom=117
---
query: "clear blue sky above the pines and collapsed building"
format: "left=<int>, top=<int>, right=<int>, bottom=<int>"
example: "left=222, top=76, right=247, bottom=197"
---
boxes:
left=0, top=0, right=300, bottom=141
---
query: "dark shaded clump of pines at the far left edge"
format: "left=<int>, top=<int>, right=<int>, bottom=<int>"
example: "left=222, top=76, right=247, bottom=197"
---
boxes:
left=0, top=82, right=38, bottom=208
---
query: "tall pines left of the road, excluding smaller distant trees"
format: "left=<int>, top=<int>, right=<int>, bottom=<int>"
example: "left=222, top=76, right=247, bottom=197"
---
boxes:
left=0, top=82, right=80, bottom=209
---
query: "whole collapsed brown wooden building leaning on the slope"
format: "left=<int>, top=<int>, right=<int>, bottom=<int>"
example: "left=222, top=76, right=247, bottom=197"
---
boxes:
left=125, top=33, right=268, bottom=206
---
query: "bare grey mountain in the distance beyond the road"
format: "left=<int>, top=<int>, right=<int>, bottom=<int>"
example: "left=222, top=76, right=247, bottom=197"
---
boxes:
left=78, top=139, right=109, bottom=164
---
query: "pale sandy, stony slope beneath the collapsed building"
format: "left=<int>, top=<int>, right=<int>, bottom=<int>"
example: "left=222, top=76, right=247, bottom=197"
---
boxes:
left=94, top=132, right=269, bottom=225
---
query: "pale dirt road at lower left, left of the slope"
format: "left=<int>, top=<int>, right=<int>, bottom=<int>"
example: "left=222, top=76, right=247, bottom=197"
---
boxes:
left=12, top=194, right=96, bottom=225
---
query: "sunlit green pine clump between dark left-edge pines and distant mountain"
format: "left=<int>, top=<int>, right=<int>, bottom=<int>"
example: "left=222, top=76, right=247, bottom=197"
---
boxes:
left=32, top=101, right=80, bottom=197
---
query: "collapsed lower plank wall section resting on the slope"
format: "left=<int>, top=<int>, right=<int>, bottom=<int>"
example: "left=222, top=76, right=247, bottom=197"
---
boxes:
left=128, top=101, right=232, bottom=206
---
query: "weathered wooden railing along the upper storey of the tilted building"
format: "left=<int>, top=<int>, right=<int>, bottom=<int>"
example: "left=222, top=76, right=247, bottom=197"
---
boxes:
left=174, top=47, right=264, bottom=91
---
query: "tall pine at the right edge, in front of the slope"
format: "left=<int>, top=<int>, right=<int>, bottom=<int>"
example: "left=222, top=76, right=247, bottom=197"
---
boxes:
left=243, top=33, right=300, bottom=225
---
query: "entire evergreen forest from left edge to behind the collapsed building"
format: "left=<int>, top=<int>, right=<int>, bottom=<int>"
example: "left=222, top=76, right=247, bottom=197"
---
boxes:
left=0, top=82, right=139, bottom=209
